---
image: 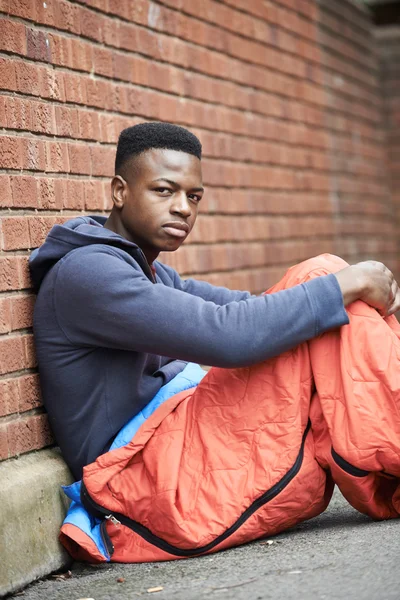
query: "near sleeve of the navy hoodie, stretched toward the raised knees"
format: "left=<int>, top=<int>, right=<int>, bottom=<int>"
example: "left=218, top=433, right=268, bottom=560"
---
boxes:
left=54, top=247, right=348, bottom=367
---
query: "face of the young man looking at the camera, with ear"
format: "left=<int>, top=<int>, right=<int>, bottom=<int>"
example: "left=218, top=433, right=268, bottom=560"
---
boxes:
left=112, top=149, right=204, bottom=263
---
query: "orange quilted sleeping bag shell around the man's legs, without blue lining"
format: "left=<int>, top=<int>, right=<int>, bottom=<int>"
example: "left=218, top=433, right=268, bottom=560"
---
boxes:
left=61, top=255, right=400, bottom=562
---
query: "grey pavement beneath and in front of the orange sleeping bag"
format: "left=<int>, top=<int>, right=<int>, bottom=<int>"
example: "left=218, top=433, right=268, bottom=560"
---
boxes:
left=13, top=493, right=400, bottom=600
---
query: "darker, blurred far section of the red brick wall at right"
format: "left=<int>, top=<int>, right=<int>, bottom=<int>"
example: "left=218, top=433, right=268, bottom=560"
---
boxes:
left=319, top=0, right=400, bottom=274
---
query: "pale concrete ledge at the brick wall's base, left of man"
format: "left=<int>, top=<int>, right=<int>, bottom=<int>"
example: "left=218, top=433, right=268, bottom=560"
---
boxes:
left=0, top=448, right=73, bottom=597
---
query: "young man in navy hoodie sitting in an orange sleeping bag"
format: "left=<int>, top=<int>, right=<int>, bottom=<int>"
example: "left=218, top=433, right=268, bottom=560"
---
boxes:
left=30, top=123, right=400, bottom=562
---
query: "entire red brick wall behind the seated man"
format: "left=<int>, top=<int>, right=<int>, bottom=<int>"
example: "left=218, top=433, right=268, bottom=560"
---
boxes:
left=0, top=0, right=395, bottom=459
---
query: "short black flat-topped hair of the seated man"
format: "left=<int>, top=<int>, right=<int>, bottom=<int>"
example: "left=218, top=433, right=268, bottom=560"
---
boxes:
left=115, top=122, right=201, bottom=173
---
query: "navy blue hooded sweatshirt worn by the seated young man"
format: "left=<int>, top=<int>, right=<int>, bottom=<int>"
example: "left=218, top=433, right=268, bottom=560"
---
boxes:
left=30, top=217, right=348, bottom=478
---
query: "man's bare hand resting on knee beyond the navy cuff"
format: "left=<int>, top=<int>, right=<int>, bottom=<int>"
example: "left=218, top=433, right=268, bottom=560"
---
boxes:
left=335, top=260, right=400, bottom=317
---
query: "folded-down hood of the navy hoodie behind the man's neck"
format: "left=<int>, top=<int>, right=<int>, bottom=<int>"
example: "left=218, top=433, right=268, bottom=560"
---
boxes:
left=29, top=216, right=145, bottom=291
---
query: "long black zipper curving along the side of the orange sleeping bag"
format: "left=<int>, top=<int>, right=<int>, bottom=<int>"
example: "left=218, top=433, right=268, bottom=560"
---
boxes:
left=81, top=421, right=311, bottom=557
